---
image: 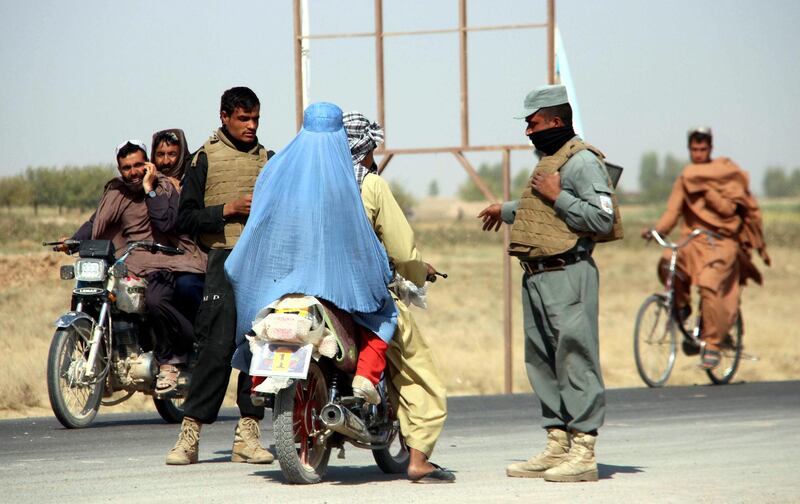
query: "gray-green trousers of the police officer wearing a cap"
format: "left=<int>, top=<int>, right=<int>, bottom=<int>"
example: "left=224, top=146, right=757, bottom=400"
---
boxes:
left=522, top=258, right=606, bottom=432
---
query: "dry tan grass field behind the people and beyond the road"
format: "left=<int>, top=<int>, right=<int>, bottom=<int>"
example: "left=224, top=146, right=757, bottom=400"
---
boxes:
left=0, top=202, right=800, bottom=417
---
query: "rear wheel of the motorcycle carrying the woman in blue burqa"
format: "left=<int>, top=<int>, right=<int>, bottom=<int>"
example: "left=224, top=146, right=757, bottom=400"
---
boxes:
left=272, top=362, right=331, bottom=484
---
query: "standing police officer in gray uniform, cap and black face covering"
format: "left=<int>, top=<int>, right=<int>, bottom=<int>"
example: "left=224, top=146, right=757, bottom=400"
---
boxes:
left=478, top=86, right=622, bottom=481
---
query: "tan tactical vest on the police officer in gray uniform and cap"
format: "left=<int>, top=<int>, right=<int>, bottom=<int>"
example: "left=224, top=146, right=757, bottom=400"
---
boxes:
left=508, top=138, right=623, bottom=258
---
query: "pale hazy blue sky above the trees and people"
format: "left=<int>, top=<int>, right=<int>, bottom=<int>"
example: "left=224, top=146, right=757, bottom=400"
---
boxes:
left=0, top=0, right=800, bottom=195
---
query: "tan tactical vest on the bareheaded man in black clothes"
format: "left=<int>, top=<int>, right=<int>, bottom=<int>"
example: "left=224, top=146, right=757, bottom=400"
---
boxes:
left=192, top=131, right=267, bottom=249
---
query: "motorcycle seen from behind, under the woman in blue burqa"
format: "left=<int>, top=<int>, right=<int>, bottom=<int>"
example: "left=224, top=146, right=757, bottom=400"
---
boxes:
left=248, top=272, right=447, bottom=484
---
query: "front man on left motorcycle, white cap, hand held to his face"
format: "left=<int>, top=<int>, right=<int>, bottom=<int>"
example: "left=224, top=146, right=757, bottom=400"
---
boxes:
left=62, top=140, right=206, bottom=394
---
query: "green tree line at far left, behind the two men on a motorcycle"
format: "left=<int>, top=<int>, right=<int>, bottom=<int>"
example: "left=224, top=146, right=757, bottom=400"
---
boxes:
left=0, top=164, right=118, bottom=213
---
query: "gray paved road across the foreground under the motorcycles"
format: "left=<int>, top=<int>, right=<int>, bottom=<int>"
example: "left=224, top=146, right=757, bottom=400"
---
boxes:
left=0, top=382, right=800, bottom=504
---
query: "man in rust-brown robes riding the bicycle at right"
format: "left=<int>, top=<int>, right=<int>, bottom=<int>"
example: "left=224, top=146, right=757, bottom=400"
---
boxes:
left=642, top=127, right=770, bottom=369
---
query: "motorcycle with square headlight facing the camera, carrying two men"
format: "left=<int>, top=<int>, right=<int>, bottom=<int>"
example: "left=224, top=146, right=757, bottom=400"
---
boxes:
left=42, top=240, right=194, bottom=429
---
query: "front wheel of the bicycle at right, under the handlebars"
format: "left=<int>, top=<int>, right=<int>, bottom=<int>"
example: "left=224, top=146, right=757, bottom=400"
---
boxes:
left=633, top=294, right=677, bottom=387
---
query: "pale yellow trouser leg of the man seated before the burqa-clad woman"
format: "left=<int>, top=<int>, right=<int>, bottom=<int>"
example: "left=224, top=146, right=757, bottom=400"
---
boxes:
left=386, top=298, right=447, bottom=457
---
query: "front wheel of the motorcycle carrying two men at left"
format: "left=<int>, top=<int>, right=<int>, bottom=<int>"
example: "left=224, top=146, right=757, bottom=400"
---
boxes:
left=47, top=325, right=105, bottom=429
